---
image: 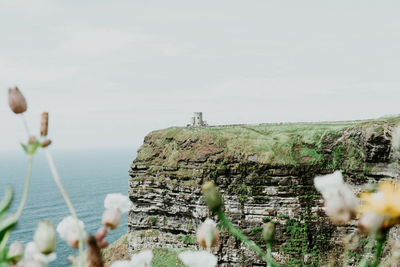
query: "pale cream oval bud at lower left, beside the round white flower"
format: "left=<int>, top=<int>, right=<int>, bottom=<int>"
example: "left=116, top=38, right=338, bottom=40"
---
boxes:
left=33, top=220, right=57, bottom=255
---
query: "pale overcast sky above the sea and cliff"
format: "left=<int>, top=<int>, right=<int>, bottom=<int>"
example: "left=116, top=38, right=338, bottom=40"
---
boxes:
left=0, top=0, right=400, bottom=150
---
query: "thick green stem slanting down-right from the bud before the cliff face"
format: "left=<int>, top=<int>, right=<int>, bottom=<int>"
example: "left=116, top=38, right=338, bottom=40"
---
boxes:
left=215, top=208, right=279, bottom=267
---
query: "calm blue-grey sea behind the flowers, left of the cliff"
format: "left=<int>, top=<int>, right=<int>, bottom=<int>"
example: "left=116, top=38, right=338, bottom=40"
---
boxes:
left=0, top=149, right=136, bottom=266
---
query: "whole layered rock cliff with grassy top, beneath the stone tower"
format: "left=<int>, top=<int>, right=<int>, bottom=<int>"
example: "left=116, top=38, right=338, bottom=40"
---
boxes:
left=128, top=118, right=400, bottom=266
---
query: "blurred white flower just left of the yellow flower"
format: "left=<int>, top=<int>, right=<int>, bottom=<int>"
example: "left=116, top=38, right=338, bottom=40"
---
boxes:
left=314, top=171, right=358, bottom=225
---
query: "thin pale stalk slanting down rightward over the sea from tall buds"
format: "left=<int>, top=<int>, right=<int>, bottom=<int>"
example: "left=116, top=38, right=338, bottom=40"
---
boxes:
left=46, top=149, right=83, bottom=266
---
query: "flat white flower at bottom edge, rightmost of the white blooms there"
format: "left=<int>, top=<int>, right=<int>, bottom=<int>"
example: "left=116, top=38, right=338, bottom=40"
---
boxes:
left=178, top=250, right=217, bottom=267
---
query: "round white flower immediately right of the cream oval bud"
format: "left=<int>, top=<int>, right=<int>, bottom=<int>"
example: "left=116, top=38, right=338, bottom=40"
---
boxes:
left=57, top=216, right=86, bottom=248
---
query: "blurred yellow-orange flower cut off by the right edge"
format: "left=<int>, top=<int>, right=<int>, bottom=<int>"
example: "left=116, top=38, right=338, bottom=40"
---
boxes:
left=358, top=181, right=400, bottom=222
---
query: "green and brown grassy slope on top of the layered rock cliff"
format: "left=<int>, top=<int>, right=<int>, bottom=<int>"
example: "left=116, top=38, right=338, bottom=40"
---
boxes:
left=136, top=117, right=400, bottom=167
